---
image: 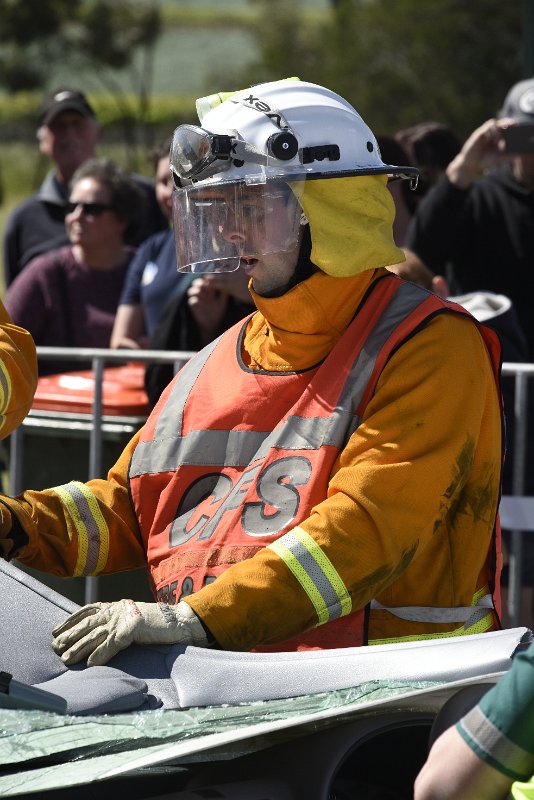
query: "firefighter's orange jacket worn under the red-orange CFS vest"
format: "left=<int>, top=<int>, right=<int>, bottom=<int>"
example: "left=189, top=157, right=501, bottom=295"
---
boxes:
left=0, top=270, right=502, bottom=650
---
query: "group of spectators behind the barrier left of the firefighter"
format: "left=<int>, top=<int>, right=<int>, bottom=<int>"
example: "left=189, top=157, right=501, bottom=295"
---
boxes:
left=3, top=87, right=253, bottom=403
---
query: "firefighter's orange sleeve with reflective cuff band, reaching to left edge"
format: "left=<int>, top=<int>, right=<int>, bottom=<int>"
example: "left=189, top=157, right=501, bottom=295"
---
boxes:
left=0, top=433, right=146, bottom=577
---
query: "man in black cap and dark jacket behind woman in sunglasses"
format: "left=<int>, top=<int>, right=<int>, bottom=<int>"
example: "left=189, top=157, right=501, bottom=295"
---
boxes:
left=4, top=87, right=166, bottom=286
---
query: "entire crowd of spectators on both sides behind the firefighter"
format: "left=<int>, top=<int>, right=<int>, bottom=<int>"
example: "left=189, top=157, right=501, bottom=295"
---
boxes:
left=3, top=72, right=534, bottom=797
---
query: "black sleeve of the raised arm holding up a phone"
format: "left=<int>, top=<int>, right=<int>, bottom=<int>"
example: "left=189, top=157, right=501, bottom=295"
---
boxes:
left=405, top=177, right=470, bottom=274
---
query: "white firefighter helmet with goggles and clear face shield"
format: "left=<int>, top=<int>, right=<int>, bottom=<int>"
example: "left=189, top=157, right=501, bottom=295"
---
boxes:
left=170, top=79, right=417, bottom=277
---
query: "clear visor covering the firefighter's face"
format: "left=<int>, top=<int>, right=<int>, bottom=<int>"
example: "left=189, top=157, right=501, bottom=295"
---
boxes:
left=173, top=182, right=302, bottom=273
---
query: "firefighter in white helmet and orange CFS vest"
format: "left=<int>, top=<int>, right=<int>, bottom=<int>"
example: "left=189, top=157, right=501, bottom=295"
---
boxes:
left=0, top=79, right=502, bottom=665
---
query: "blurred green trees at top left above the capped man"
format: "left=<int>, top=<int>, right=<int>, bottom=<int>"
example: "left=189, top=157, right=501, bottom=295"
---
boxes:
left=0, top=0, right=161, bottom=160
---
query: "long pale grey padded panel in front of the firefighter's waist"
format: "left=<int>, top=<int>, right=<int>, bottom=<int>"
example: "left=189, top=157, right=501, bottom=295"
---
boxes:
left=171, top=628, right=530, bottom=708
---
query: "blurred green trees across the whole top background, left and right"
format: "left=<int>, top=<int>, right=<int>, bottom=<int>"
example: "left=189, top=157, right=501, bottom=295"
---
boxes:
left=0, top=0, right=532, bottom=148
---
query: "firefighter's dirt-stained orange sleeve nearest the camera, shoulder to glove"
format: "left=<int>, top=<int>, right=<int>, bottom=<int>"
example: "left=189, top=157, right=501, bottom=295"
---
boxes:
left=187, top=314, right=502, bottom=650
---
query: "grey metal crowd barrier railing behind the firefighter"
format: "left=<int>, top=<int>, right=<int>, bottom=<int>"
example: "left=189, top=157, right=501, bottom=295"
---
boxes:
left=5, top=354, right=534, bottom=625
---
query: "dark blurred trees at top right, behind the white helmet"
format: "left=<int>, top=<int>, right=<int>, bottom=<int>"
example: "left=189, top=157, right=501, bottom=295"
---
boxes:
left=242, top=0, right=524, bottom=136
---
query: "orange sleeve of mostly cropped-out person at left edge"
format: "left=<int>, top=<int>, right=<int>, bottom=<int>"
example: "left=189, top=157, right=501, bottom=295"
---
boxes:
left=0, top=302, right=37, bottom=439
